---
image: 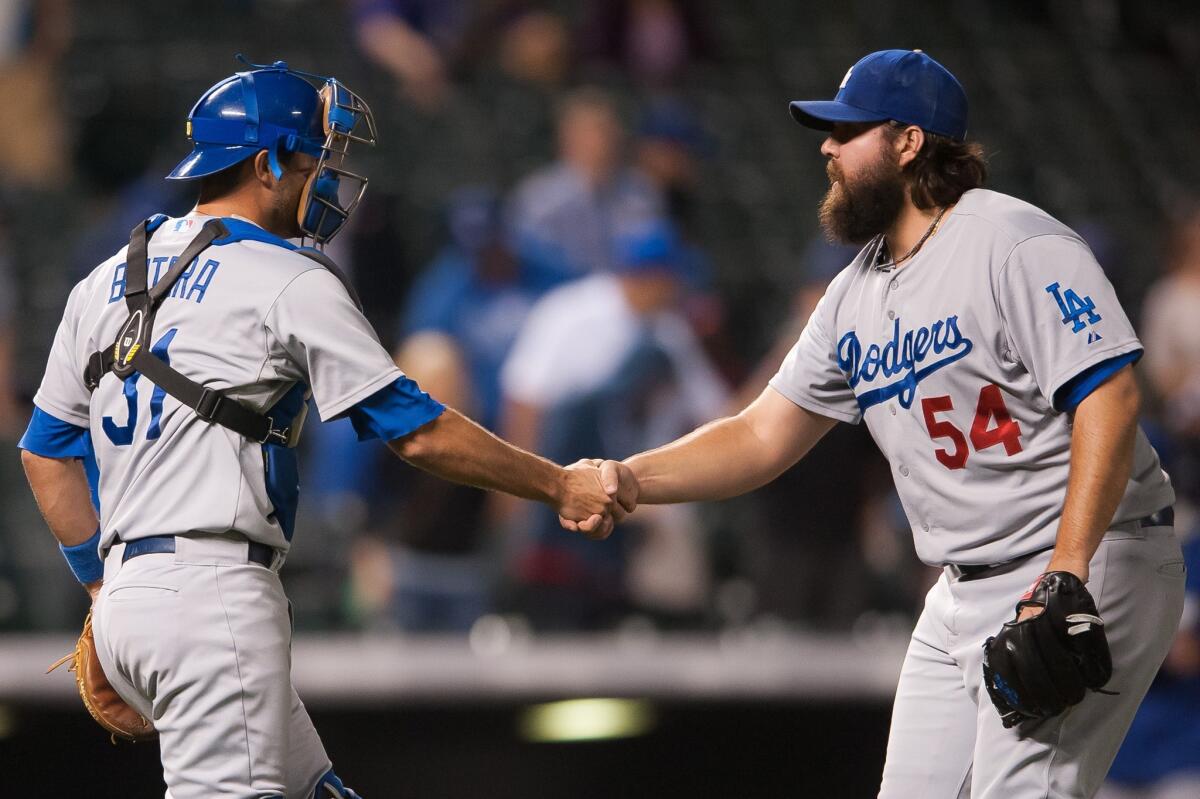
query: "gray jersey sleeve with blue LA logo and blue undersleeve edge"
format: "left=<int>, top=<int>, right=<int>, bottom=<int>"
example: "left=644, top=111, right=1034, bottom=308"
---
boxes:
left=997, top=235, right=1142, bottom=410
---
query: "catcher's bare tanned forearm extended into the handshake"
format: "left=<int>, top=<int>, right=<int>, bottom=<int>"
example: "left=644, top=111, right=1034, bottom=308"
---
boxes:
left=389, top=408, right=564, bottom=504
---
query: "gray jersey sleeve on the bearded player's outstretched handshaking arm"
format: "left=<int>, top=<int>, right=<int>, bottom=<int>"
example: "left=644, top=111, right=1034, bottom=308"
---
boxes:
left=768, top=292, right=863, bottom=425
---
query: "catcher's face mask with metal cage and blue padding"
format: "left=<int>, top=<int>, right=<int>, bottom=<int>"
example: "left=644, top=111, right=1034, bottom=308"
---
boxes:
left=296, top=78, right=376, bottom=245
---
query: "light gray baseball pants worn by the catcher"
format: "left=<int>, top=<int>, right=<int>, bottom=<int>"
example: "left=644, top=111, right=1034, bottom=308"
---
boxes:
left=92, top=534, right=330, bottom=799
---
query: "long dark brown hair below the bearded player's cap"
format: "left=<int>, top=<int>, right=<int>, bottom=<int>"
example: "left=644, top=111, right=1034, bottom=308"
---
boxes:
left=887, top=120, right=988, bottom=210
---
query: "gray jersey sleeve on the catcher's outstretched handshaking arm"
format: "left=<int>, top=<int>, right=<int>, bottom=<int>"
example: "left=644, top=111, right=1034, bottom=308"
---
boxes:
left=265, top=269, right=403, bottom=420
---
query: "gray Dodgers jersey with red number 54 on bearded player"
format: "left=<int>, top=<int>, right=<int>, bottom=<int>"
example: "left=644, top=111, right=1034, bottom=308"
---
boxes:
left=770, top=190, right=1175, bottom=564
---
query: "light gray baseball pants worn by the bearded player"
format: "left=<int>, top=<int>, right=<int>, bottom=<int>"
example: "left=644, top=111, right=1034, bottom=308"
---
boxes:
left=878, top=523, right=1184, bottom=799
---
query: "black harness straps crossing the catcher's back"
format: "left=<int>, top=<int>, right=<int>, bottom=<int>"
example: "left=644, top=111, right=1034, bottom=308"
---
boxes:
left=84, top=220, right=340, bottom=446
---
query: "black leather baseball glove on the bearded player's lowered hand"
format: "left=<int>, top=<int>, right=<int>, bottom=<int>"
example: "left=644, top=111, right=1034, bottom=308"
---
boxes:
left=983, top=571, right=1112, bottom=727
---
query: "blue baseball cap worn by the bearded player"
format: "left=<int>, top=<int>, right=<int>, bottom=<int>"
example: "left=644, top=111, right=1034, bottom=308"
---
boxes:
left=788, top=50, right=967, bottom=142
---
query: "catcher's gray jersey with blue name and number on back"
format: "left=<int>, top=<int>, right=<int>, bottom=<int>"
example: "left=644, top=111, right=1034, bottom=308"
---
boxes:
left=34, top=212, right=402, bottom=551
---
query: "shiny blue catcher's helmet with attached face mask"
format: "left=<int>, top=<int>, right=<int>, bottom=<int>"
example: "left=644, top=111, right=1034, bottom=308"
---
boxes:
left=167, top=56, right=376, bottom=245
